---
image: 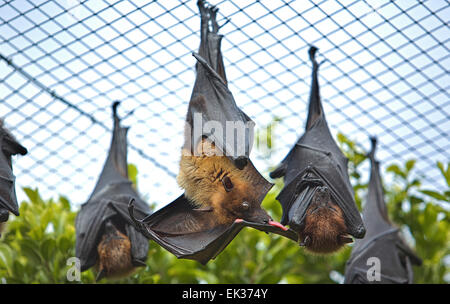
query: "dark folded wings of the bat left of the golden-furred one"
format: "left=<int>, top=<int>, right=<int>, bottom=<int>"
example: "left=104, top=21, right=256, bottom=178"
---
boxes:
left=75, top=102, right=150, bottom=271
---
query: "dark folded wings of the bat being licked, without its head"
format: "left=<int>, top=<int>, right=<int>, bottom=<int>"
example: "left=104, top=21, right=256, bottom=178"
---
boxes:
left=270, top=47, right=365, bottom=238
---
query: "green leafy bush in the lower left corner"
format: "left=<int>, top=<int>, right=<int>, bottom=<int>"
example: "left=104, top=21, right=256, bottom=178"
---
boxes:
left=0, top=188, right=92, bottom=283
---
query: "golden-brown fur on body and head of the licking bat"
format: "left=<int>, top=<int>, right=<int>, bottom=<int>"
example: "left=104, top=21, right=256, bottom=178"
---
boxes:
left=177, top=140, right=271, bottom=224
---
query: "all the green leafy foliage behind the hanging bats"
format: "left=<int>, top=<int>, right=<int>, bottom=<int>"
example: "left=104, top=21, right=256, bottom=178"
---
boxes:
left=0, top=134, right=450, bottom=283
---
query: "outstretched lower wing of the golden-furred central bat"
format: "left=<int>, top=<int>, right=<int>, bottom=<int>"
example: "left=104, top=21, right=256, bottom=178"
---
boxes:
left=130, top=195, right=297, bottom=265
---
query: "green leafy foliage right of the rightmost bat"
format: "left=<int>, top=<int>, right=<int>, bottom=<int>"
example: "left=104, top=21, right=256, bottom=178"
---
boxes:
left=387, top=160, right=450, bottom=283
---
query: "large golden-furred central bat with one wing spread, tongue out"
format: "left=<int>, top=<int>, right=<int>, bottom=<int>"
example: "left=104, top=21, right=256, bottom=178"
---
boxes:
left=130, top=1, right=296, bottom=264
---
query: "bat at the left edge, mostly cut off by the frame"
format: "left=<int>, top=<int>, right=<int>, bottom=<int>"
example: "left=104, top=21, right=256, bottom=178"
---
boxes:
left=0, top=120, right=28, bottom=236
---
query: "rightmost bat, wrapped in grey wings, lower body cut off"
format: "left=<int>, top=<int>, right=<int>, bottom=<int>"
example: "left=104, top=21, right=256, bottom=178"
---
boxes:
left=344, top=138, right=422, bottom=284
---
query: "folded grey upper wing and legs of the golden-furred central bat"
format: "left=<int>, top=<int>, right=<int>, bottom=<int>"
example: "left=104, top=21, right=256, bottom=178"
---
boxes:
left=185, top=1, right=254, bottom=169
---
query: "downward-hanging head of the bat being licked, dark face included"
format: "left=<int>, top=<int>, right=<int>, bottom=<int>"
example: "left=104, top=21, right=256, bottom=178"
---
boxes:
left=291, top=186, right=352, bottom=254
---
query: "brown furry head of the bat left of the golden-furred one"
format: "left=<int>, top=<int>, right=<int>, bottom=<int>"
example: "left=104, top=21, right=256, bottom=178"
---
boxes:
left=97, top=224, right=135, bottom=279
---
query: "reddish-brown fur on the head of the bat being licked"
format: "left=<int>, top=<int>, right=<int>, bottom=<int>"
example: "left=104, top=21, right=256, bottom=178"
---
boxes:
left=300, top=201, right=347, bottom=254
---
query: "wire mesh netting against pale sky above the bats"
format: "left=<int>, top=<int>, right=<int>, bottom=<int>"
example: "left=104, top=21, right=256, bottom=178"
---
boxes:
left=0, top=0, right=450, bottom=208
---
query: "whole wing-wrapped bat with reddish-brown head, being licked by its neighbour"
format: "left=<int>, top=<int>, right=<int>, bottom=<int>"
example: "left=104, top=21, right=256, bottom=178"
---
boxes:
left=270, top=47, right=365, bottom=253
